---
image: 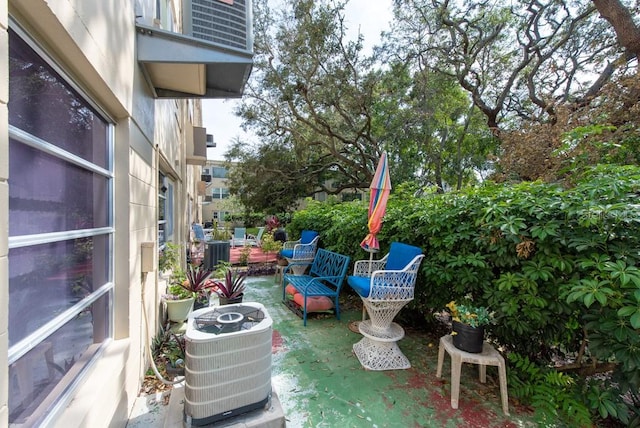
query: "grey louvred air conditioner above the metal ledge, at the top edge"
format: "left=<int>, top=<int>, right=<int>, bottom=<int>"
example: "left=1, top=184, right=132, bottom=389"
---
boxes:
left=182, top=0, right=253, bottom=52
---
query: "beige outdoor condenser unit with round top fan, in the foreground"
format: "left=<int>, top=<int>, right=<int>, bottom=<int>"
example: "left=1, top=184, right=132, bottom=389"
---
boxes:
left=184, top=302, right=273, bottom=426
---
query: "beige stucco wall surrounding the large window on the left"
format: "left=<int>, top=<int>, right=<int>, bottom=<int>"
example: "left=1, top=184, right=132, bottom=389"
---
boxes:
left=0, top=0, right=201, bottom=428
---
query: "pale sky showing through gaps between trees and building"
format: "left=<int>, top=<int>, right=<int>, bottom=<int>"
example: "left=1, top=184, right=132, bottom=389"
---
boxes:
left=202, top=0, right=392, bottom=160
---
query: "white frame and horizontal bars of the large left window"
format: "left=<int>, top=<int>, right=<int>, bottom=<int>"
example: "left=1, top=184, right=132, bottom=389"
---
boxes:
left=7, top=20, right=116, bottom=425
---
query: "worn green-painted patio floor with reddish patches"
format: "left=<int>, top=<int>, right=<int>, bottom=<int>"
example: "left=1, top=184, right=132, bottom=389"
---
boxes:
left=128, top=277, right=536, bottom=428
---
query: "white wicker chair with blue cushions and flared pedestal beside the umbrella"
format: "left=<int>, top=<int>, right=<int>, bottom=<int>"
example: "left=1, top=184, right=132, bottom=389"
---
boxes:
left=348, top=242, right=424, bottom=370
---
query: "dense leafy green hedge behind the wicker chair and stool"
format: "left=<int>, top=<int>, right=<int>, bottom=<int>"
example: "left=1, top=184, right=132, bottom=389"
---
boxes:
left=288, top=166, right=640, bottom=424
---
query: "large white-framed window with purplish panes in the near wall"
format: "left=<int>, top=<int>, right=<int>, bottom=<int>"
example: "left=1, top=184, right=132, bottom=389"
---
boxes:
left=8, top=29, right=113, bottom=426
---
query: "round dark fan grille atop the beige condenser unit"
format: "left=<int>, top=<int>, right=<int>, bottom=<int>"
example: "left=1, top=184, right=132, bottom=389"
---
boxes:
left=193, top=305, right=265, bottom=334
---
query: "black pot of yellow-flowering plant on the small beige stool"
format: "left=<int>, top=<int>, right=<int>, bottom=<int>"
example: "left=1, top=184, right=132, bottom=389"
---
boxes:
left=446, top=300, right=493, bottom=354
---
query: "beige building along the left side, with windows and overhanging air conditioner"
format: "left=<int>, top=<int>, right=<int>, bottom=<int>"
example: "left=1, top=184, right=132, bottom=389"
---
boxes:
left=0, top=0, right=253, bottom=428
